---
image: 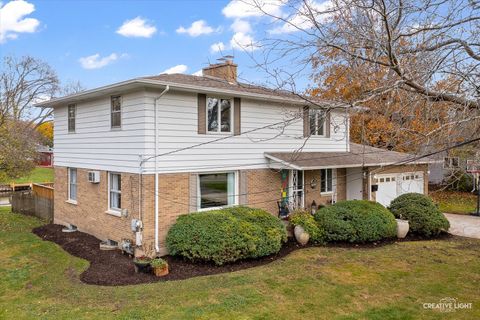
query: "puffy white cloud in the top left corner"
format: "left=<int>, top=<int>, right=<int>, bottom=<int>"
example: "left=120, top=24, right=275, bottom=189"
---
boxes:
left=0, top=0, right=40, bottom=43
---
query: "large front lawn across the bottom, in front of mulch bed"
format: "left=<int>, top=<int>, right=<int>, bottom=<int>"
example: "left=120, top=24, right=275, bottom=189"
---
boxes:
left=0, top=208, right=480, bottom=320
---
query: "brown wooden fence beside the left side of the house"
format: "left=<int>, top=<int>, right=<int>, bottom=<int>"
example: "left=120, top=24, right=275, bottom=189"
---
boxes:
left=12, top=183, right=54, bottom=222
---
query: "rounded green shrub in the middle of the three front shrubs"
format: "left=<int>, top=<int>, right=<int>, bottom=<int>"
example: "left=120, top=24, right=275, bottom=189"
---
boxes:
left=314, top=200, right=396, bottom=242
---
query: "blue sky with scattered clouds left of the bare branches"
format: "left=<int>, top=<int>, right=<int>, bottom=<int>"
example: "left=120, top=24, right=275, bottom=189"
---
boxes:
left=0, top=0, right=316, bottom=88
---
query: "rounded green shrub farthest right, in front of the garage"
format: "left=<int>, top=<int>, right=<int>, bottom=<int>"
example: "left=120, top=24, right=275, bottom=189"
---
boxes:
left=390, top=193, right=450, bottom=237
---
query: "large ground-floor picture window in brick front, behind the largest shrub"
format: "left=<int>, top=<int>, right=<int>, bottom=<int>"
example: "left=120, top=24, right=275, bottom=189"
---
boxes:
left=198, top=172, right=236, bottom=209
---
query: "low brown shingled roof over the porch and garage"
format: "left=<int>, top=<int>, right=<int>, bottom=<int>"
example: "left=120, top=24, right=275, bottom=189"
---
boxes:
left=265, top=143, right=436, bottom=170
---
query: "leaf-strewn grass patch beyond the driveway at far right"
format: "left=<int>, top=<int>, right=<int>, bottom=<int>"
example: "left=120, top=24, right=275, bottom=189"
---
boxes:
left=430, top=191, right=477, bottom=214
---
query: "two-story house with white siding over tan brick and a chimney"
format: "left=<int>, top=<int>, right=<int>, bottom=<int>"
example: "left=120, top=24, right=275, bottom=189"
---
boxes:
left=34, top=61, right=428, bottom=254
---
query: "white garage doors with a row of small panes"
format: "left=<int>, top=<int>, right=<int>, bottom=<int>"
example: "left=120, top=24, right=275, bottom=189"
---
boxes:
left=374, top=172, right=424, bottom=207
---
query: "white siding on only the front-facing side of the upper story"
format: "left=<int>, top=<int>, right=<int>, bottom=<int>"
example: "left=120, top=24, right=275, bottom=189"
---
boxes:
left=145, top=91, right=348, bottom=173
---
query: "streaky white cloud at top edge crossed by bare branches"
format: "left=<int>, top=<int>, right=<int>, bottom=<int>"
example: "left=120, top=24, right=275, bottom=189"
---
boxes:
left=268, top=0, right=333, bottom=34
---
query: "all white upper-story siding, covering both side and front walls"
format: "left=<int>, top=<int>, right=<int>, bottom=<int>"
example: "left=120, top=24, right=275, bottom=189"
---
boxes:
left=54, top=89, right=348, bottom=174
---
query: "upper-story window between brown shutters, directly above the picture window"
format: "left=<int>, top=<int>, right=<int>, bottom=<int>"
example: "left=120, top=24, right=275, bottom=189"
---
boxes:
left=207, top=97, right=233, bottom=133
